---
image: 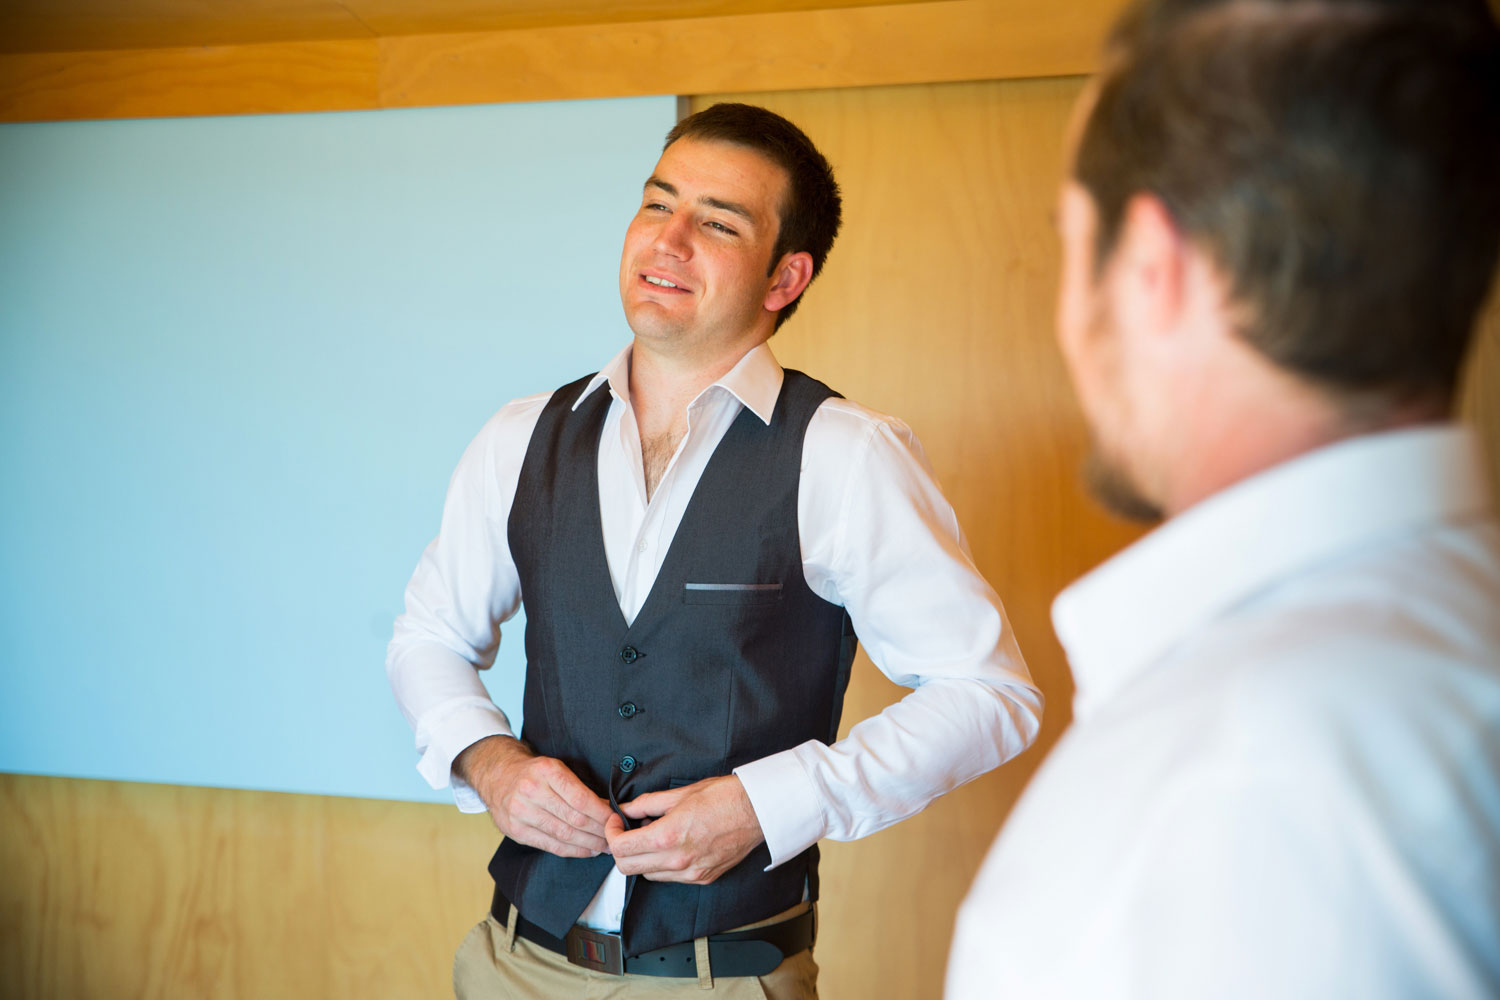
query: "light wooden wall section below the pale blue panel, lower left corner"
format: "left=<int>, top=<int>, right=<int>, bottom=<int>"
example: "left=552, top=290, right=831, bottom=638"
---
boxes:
left=0, top=775, right=498, bottom=1000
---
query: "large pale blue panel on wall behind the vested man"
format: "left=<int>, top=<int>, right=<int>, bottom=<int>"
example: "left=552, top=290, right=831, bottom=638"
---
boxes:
left=0, top=97, right=677, bottom=801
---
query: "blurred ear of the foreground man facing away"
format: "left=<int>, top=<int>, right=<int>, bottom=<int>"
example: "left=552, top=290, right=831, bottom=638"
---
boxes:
left=1109, top=195, right=1188, bottom=346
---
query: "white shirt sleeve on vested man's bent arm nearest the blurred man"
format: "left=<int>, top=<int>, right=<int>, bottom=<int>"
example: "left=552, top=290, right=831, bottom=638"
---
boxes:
left=737, top=400, right=1041, bottom=864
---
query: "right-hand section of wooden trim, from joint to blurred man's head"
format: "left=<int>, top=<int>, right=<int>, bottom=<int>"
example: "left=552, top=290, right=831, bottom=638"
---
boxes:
left=381, top=0, right=1118, bottom=106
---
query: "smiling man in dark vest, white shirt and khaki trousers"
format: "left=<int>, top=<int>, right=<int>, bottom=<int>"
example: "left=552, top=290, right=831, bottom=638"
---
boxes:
left=387, top=105, right=1041, bottom=997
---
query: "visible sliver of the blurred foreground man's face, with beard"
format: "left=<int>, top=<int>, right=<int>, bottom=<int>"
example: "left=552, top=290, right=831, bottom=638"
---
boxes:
left=1058, top=178, right=1161, bottom=520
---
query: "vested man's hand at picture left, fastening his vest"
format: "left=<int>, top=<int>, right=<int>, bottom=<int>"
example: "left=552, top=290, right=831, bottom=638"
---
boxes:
left=453, top=736, right=614, bottom=858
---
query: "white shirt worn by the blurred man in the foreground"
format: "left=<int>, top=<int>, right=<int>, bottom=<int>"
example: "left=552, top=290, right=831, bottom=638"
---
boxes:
left=947, top=426, right=1500, bottom=1000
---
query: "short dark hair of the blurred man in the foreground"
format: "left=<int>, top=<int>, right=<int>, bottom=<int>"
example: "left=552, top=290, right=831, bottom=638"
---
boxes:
left=1074, top=0, right=1500, bottom=406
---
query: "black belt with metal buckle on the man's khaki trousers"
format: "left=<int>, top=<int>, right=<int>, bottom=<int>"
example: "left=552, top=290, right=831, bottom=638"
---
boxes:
left=491, top=888, right=816, bottom=978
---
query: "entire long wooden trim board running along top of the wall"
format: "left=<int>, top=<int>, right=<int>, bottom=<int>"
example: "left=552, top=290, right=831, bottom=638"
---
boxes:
left=0, top=0, right=1118, bottom=121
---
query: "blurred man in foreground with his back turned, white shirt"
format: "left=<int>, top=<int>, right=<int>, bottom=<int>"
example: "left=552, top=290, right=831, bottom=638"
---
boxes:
left=947, top=0, right=1500, bottom=1000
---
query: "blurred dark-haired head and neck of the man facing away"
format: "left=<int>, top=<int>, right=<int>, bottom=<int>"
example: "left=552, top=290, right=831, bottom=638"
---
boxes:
left=1059, top=0, right=1500, bottom=516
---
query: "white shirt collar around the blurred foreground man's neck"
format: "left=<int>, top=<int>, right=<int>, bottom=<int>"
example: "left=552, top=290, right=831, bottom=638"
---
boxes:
left=1052, top=424, right=1488, bottom=718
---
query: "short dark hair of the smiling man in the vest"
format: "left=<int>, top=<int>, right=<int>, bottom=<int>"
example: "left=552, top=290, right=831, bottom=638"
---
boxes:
left=663, top=103, right=843, bottom=328
